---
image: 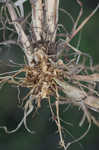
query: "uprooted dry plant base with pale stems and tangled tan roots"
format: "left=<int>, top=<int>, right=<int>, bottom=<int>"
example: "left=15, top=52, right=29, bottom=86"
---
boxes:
left=0, top=0, right=99, bottom=150
